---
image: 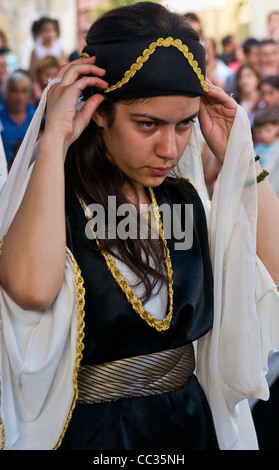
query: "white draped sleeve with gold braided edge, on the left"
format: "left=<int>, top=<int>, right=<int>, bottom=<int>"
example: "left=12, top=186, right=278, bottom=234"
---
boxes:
left=0, top=80, right=84, bottom=450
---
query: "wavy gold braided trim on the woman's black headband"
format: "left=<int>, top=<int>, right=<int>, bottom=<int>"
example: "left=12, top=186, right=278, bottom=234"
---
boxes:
left=104, top=37, right=208, bottom=93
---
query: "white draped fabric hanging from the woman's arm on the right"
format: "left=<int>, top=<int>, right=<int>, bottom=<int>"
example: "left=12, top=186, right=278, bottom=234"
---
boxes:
left=182, top=106, right=279, bottom=450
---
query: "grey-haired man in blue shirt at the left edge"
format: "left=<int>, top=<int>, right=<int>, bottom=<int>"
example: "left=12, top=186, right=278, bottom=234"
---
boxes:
left=0, top=71, right=35, bottom=164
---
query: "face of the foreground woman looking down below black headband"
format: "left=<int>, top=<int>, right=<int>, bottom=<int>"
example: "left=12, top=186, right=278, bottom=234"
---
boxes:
left=93, top=96, right=200, bottom=193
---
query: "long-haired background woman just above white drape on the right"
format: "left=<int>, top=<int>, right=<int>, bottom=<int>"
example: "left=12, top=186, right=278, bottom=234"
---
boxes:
left=234, top=64, right=260, bottom=125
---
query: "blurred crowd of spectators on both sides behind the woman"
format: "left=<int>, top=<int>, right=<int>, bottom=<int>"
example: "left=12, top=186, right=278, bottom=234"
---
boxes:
left=0, top=10, right=279, bottom=196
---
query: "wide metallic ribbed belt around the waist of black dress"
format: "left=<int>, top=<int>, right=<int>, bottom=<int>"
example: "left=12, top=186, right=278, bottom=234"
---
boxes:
left=78, top=343, right=195, bottom=404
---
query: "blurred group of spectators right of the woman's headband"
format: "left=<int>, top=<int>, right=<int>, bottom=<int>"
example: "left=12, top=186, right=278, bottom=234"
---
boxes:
left=185, top=10, right=279, bottom=196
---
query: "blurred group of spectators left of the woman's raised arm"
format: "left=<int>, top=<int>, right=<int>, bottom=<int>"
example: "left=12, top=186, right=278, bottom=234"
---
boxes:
left=0, top=17, right=75, bottom=170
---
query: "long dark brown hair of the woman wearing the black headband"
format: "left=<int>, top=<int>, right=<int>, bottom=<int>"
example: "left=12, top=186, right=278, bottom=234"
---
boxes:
left=65, top=2, right=199, bottom=301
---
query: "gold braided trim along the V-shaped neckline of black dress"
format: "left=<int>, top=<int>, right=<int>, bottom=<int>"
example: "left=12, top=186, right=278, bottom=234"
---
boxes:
left=79, top=188, right=173, bottom=331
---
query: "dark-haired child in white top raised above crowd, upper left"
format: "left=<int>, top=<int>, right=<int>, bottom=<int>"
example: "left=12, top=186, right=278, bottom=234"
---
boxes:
left=29, top=17, right=68, bottom=76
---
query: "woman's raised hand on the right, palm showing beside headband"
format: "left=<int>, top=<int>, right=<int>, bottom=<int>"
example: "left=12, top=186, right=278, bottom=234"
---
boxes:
left=199, top=80, right=237, bottom=163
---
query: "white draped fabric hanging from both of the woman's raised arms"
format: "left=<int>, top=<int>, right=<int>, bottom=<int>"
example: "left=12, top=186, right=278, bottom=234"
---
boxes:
left=0, top=81, right=279, bottom=449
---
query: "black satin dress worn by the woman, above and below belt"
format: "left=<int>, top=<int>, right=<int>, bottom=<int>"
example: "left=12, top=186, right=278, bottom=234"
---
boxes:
left=60, top=179, right=218, bottom=452
